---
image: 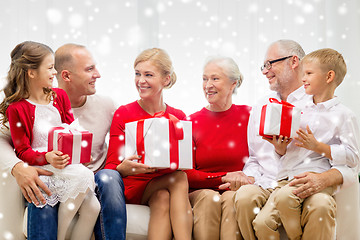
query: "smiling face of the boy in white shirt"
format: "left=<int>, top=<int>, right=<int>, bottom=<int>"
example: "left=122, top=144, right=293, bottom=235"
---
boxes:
left=302, top=60, right=328, bottom=96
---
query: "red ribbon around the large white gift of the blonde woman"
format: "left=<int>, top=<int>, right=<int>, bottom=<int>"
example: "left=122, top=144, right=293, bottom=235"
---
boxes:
left=136, top=112, right=184, bottom=168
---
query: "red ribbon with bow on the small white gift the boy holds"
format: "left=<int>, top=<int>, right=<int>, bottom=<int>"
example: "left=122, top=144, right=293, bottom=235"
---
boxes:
left=259, top=98, right=294, bottom=138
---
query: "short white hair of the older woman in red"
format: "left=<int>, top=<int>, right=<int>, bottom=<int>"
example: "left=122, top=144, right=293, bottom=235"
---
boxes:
left=204, top=56, right=244, bottom=93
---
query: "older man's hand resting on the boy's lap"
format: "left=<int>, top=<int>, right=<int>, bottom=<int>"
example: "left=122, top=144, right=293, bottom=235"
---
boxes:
left=289, top=172, right=330, bottom=198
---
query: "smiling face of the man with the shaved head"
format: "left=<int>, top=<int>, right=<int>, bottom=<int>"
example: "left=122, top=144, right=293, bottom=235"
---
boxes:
left=70, top=48, right=101, bottom=95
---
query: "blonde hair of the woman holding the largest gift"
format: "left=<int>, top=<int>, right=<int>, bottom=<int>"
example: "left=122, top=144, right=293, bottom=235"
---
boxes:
left=134, top=48, right=176, bottom=89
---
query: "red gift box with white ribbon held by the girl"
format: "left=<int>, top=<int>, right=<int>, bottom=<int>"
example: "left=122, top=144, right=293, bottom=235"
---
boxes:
left=48, top=120, right=93, bottom=164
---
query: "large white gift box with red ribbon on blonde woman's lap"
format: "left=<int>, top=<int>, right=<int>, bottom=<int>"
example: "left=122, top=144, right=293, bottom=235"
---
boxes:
left=125, top=112, right=193, bottom=170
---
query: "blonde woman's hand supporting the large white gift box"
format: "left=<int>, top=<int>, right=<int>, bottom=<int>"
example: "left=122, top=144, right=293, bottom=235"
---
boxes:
left=116, top=155, right=156, bottom=177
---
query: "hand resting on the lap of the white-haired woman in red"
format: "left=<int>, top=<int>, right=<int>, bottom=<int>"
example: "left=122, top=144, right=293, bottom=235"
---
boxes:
left=219, top=171, right=254, bottom=191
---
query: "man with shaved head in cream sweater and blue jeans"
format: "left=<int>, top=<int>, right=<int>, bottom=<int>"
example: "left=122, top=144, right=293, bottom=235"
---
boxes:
left=0, top=44, right=126, bottom=240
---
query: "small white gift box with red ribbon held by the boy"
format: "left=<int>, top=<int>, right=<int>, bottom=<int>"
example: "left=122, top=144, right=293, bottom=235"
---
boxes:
left=259, top=98, right=301, bottom=138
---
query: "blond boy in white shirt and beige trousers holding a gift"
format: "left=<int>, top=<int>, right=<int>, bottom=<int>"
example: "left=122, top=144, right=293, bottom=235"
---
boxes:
left=262, top=49, right=360, bottom=239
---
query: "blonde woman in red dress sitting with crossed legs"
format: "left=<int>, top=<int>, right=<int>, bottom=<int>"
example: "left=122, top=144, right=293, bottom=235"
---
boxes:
left=104, top=48, right=192, bottom=240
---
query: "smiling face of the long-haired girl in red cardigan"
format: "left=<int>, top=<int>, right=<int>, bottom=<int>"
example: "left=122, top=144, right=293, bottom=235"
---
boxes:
left=32, top=53, right=57, bottom=88
